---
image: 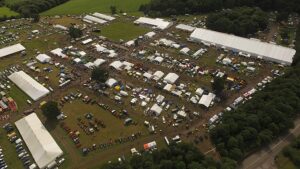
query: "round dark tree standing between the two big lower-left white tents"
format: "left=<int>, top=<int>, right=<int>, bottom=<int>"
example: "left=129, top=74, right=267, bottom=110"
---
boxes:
left=41, top=101, right=61, bottom=120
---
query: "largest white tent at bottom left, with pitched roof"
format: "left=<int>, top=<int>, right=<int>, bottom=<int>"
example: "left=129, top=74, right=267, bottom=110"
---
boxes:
left=15, top=113, right=63, bottom=169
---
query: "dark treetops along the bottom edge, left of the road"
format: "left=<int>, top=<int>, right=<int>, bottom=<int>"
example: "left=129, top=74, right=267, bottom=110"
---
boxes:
left=103, top=143, right=237, bottom=169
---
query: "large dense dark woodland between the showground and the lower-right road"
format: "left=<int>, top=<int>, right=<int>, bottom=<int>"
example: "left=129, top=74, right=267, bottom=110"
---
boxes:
left=210, top=25, right=300, bottom=160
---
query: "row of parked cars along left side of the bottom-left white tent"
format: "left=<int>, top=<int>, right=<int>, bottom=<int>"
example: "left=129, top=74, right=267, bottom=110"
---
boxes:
left=0, top=123, right=37, bottom=169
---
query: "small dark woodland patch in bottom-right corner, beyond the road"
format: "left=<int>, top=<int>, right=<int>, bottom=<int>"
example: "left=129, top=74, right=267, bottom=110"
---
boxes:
left=283, top=136, right=300, bottom=167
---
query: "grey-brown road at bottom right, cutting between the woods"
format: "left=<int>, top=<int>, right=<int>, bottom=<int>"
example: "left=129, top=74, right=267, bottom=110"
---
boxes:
left=240, top=119, right=300, bottom=169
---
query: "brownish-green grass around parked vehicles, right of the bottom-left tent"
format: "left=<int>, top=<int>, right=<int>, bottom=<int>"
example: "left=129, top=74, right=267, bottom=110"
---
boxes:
left=62, top=100, right=145, bottom=146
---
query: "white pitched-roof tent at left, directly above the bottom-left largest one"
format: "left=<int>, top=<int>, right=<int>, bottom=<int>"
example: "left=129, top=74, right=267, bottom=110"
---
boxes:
left=8, top=71, right=50, bottom=101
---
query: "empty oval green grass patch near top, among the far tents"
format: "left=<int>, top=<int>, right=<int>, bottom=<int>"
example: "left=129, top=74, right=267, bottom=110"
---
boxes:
left=101, top=21, right=150, bottom=41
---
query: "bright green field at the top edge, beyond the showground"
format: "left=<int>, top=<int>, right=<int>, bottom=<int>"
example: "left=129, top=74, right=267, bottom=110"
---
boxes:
left=42, top=0, right=149, bottom=15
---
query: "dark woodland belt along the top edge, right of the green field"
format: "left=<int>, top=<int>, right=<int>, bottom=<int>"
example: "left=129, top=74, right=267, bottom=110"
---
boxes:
left=140, top=0, right=300, bottom=16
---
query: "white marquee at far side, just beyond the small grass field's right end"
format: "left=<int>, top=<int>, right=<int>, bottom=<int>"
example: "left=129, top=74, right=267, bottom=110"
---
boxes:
left=134, top=17, right=172, bottom=30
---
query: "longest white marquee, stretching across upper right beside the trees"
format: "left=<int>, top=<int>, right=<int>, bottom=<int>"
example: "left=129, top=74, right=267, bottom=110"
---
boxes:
left=190, top=28, right=296, bottom=65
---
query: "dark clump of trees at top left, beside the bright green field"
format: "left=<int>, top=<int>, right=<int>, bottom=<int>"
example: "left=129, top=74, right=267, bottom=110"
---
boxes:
left=8, top=0, right=68, bottom=17
